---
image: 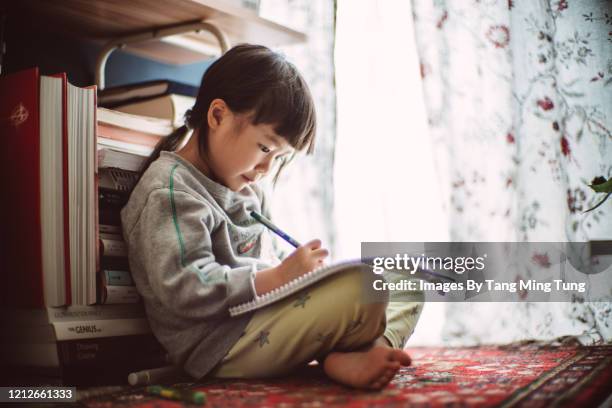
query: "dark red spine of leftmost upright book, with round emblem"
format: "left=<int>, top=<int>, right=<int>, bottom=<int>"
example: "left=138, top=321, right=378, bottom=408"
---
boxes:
left=0, top=68, right=44, bottom=307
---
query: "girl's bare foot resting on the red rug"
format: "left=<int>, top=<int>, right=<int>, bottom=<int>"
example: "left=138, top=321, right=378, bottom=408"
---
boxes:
left=323, top=341, right=410, bottom=390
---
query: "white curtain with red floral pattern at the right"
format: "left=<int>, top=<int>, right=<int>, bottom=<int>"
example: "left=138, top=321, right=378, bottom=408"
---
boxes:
left=412, top=0, right=612, bottom=344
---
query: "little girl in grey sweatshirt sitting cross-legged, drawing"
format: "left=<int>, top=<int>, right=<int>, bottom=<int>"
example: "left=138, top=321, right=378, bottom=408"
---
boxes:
left=121, top=45, right=421, bottom=389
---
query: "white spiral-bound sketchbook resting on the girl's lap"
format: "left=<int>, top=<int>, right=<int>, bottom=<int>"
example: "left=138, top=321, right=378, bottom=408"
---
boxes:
left=229, top=259, right=454, bottom=317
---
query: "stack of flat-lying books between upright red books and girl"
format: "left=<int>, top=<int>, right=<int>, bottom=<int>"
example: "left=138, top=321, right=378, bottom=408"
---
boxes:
left=97, top=81, right=197, bottom=304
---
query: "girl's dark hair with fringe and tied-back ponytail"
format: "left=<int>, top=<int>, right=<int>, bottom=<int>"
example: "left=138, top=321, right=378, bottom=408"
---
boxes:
left=141, top=44, right=316, bottom=183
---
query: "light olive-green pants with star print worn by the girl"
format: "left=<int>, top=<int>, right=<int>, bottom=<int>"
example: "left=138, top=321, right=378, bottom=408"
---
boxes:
left=211, top=270, right=422, bottom=378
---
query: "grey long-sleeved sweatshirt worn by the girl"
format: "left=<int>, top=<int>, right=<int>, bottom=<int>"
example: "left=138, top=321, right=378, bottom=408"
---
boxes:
left=121, top=152, right=278, bottom=378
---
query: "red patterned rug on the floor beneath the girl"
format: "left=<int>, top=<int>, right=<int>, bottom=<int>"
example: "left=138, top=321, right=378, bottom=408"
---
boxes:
left=78, top=344, right=612, bottom=408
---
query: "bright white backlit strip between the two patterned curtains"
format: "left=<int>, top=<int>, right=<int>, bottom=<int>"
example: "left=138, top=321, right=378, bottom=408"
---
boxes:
left=333, top=0, right=448, bottom=344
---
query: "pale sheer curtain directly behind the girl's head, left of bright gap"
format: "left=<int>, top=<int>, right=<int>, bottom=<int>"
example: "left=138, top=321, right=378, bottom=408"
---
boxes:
left=260, top=0, right=336, bottom=252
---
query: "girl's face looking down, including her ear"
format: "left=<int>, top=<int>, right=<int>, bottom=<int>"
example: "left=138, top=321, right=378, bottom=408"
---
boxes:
left=207, top=100, right=294, bottom=191
